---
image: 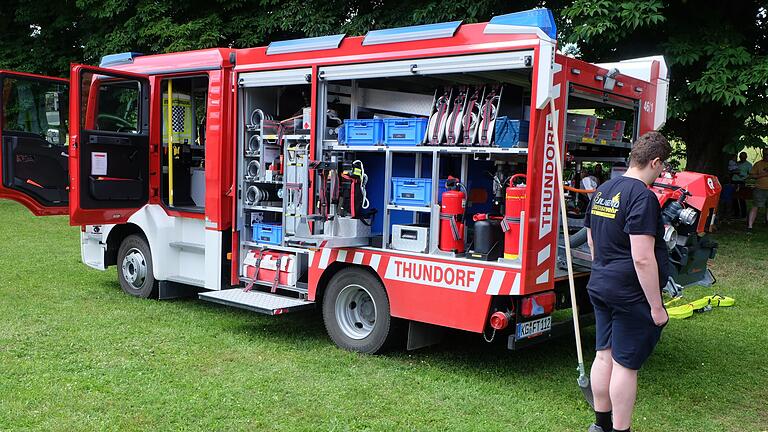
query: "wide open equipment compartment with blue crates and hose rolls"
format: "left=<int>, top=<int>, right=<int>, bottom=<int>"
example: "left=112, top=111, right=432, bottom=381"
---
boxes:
left=316, top=51, right=533, bottom=267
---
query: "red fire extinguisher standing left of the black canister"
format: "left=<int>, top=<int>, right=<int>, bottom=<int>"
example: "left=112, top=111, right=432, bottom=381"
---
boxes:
left=439, top=176, right=467, bottom=253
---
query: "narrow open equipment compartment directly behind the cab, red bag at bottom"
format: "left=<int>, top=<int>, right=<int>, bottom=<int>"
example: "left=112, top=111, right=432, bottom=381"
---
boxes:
left=236, top=68, right=312, bottom=294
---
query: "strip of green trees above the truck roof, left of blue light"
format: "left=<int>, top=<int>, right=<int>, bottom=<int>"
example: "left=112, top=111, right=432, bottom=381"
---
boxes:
left=0, top=0, right=541, bottom=76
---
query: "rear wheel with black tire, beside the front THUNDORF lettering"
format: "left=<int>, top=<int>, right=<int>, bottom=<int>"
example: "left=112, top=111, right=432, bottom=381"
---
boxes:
left=323, top=267, right=395, bottom=354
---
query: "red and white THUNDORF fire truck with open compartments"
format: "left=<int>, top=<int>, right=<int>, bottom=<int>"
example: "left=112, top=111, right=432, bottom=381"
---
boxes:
left=0, top=9, right=720, bottom=353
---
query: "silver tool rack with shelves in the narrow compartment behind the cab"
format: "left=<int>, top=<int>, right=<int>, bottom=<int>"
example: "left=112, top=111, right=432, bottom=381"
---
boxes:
left=236, top=73, right=310, bottom=294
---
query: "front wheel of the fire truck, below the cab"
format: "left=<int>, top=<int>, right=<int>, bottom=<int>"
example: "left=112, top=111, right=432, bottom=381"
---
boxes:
left=117, top=234, right=158, bottom=298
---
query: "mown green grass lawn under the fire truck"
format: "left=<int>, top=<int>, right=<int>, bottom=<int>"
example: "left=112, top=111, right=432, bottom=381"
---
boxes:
left=0, top=201, right=768, bottom=431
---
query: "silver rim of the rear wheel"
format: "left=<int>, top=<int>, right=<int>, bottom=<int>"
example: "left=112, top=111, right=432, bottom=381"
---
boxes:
left=335, top=284, right=376, bottom=339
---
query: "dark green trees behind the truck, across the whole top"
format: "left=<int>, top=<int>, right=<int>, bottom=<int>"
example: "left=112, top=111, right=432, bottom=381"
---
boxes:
left=0, top=0, right=768, bottom=176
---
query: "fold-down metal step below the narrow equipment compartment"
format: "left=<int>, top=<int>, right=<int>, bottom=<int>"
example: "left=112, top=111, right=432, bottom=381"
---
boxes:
left=199, top=288, right=315, bottom=315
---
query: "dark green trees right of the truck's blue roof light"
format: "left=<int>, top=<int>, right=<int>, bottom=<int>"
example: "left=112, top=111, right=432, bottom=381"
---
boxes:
left=562, top=0, right=768, bottom=174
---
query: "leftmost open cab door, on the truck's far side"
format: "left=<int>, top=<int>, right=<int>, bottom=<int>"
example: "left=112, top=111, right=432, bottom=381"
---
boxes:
left=0, top=71, right=69, bottom=216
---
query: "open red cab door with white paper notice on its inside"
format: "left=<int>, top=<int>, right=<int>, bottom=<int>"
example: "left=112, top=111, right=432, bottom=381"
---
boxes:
left=69, top=65, right=150, bottom=225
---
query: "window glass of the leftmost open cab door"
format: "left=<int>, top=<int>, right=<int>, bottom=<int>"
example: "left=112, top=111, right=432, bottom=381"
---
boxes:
left=2, top=78, right=69, bottom=146
